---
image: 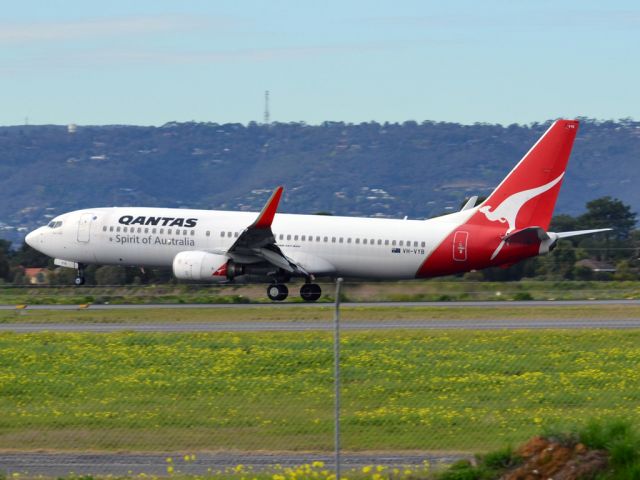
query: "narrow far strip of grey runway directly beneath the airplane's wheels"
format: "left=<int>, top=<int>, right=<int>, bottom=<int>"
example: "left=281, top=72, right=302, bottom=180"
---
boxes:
left=0, top=299, right=640, bottom=310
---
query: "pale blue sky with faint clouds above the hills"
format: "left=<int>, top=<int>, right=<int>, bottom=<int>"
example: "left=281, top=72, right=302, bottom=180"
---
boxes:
left=0, top=0, right=640, bottom=125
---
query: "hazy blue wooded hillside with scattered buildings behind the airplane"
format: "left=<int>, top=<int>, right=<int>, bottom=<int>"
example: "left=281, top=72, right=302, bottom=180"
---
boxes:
left=0, top=119, right=640, bottom=246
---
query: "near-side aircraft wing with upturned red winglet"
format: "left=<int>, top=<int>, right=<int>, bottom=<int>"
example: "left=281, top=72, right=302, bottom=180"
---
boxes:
left=224, top=187, right=311, bottom=277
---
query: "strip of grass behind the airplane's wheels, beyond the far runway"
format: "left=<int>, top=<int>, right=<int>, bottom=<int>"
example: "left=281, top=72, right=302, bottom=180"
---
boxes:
left=0, top=278, right=640, bottom=305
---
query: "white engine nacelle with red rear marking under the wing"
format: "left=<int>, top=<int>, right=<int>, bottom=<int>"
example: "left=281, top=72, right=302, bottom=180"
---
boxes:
left=173, top=250, right=236, bottom=282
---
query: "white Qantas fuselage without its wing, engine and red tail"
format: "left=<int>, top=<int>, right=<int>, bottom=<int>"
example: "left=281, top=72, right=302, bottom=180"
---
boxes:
left=27, top=207, right=477, bottom=279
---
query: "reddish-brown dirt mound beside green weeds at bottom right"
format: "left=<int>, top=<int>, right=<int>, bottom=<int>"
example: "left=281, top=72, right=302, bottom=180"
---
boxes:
left=501, top=437, right=609, bottom=480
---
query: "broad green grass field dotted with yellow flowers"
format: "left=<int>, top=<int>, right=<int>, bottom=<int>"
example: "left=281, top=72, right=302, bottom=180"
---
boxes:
left=0, top=328, right=640, bottom=452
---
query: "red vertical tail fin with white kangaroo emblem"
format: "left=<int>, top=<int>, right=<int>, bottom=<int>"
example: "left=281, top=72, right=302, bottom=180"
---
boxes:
left=479, top=120, right=579, bottom=233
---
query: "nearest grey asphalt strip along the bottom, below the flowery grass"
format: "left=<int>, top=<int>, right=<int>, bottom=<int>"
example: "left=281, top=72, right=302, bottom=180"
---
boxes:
left=0, top=452, right=462, bottom=477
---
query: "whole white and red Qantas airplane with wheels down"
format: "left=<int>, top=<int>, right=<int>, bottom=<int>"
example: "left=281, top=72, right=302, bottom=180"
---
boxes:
left=25, top=120, right=610, bottom=302
